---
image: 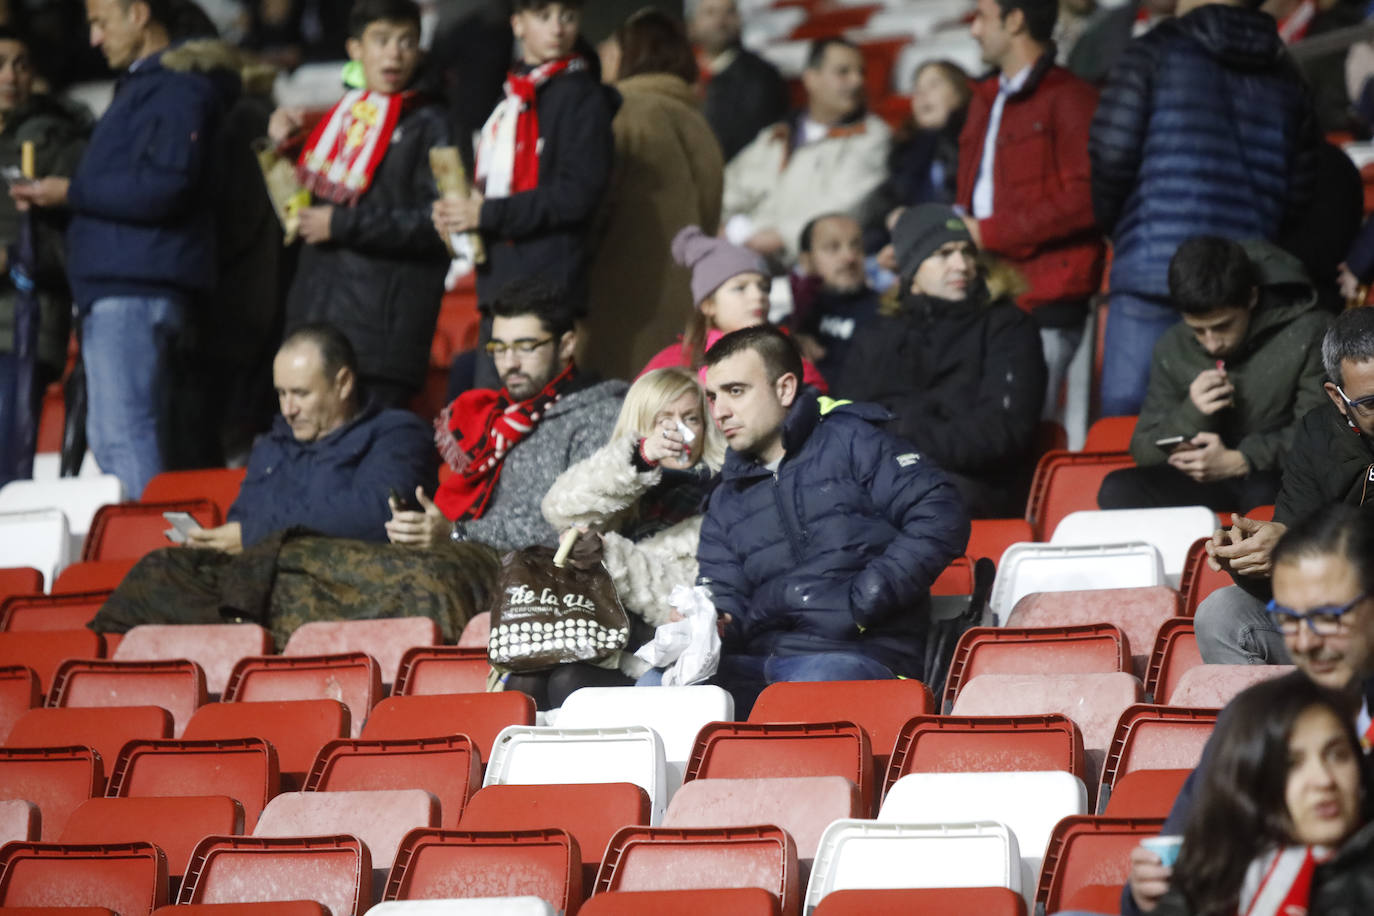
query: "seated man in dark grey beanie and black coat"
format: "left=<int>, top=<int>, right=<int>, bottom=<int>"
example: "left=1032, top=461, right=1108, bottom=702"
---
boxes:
left=833, top=203, right=1046, bottom=518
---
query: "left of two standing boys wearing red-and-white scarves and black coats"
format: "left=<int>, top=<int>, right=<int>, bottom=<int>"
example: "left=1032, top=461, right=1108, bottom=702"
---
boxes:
left=268, top=0, right=452, bottom=405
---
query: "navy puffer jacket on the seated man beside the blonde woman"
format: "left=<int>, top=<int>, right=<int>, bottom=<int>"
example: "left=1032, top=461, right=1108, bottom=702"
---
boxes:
left=697, top=387, right=969, bottom=677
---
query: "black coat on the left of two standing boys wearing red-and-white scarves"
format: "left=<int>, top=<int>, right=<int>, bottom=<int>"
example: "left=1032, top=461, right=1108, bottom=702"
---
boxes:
left=286, top=103, right=452, bottom=389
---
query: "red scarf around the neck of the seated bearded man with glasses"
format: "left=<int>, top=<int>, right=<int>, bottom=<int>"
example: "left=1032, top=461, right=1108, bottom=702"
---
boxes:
left=434, top=363, right=573, bottom=520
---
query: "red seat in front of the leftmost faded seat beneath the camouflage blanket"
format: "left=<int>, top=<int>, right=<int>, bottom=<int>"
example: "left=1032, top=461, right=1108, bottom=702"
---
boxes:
left=48, top=659, right=206, bottom=737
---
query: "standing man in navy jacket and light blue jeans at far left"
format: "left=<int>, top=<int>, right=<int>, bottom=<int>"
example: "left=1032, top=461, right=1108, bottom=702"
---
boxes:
left=14, top=0, right=239, bottom=499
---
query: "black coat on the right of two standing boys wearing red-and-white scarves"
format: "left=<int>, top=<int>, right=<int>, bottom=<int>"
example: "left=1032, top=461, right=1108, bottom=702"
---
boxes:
left=477, top=70, right=620, bottom=312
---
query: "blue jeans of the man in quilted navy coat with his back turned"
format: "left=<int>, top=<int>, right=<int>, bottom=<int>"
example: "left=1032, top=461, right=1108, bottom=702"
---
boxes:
left=1101, top=293, right=1179, bottom=416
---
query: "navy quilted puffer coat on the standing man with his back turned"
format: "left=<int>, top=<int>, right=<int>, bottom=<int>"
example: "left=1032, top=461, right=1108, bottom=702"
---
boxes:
left=1090, top=4, right=1319, bottom=298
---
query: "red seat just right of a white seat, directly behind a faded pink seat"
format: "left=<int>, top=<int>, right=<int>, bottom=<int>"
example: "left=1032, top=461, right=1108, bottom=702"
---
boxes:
left=683, top=721, right=874, bottom=818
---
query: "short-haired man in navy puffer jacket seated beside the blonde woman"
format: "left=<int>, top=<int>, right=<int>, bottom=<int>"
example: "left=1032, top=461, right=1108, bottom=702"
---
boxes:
left=697, top=325, right=969, bottom=715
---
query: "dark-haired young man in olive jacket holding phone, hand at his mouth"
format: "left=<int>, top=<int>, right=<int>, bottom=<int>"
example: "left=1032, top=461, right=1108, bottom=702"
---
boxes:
left=1098, top=236, right=1327, bottom=512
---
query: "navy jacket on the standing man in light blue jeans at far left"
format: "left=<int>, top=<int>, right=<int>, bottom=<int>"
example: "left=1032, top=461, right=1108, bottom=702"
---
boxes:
left=67, top=44, right=239, bottom=310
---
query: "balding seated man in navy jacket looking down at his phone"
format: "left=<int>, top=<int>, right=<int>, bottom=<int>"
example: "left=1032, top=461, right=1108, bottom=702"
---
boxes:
left=188, top=324, right=438, bottom=553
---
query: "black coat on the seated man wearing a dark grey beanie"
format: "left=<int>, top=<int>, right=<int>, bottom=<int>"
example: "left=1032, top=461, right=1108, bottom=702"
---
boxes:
left=831, top=290, right=1046, bottom=515
